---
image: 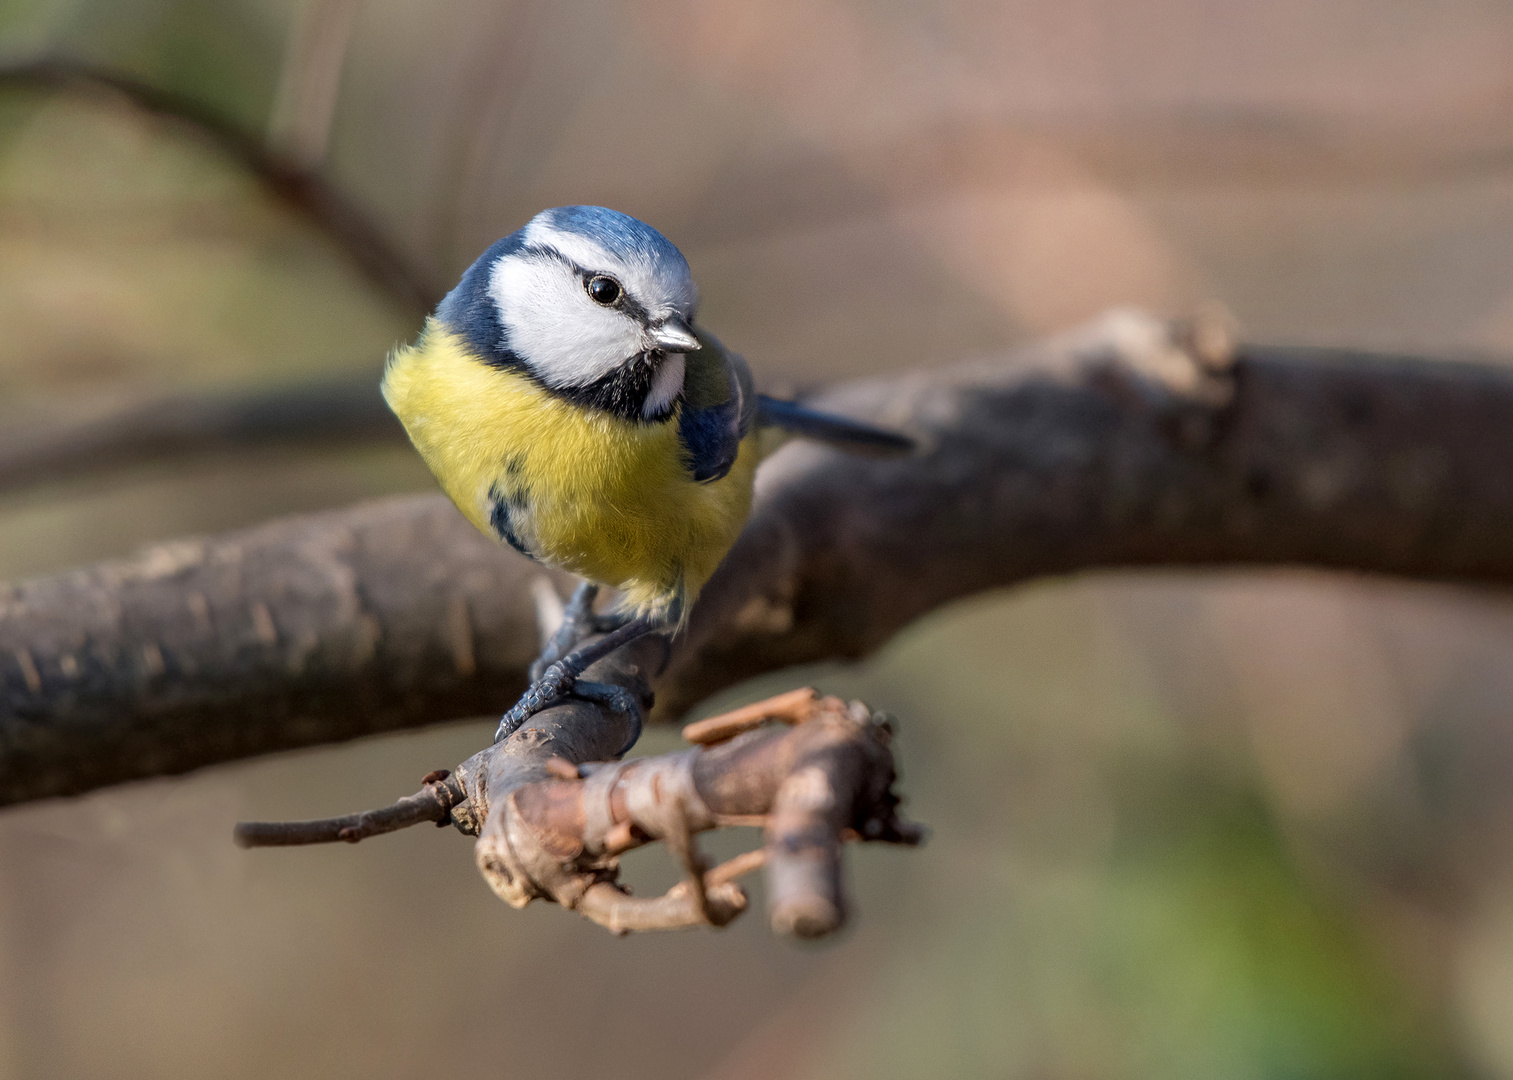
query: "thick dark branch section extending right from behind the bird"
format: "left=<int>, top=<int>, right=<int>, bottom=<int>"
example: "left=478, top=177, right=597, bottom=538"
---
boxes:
left=658, top=312, right=1513, bottom=715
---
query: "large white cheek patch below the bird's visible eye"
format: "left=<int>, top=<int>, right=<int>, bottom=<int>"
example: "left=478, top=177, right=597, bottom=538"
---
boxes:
left=489, top=257, right=643, bottom=387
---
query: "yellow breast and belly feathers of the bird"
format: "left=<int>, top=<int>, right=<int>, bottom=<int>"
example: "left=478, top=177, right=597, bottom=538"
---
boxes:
left=384, top=322, right=758, bottom=614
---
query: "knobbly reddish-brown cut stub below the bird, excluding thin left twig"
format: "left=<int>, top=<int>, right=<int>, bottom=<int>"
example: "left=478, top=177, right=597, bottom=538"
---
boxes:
left=463, top=691, right=923, bottom=938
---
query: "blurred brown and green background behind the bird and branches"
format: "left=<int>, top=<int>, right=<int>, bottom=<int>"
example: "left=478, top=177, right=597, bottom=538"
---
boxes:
left=0, top=0, right=1513, bottom=1080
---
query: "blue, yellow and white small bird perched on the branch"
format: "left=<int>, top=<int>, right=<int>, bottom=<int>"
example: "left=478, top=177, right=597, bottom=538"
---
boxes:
left=381, top=206, right=912, bottom=753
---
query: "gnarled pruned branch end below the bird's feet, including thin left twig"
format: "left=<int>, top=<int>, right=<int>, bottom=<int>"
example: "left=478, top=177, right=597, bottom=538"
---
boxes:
left=235, top=689, right=923, bottom=938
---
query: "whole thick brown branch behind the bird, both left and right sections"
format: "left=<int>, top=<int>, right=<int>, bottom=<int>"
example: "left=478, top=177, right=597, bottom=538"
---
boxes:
left=0, top=307, right=1513, bottom=802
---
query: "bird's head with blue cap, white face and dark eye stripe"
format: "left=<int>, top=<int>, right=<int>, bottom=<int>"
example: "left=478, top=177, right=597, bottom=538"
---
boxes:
left=436, top=206, right=699, bottom=421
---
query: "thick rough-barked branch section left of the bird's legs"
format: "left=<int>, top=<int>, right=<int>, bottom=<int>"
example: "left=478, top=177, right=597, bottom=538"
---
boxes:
left=0, top=496, right=564, bottom=802
